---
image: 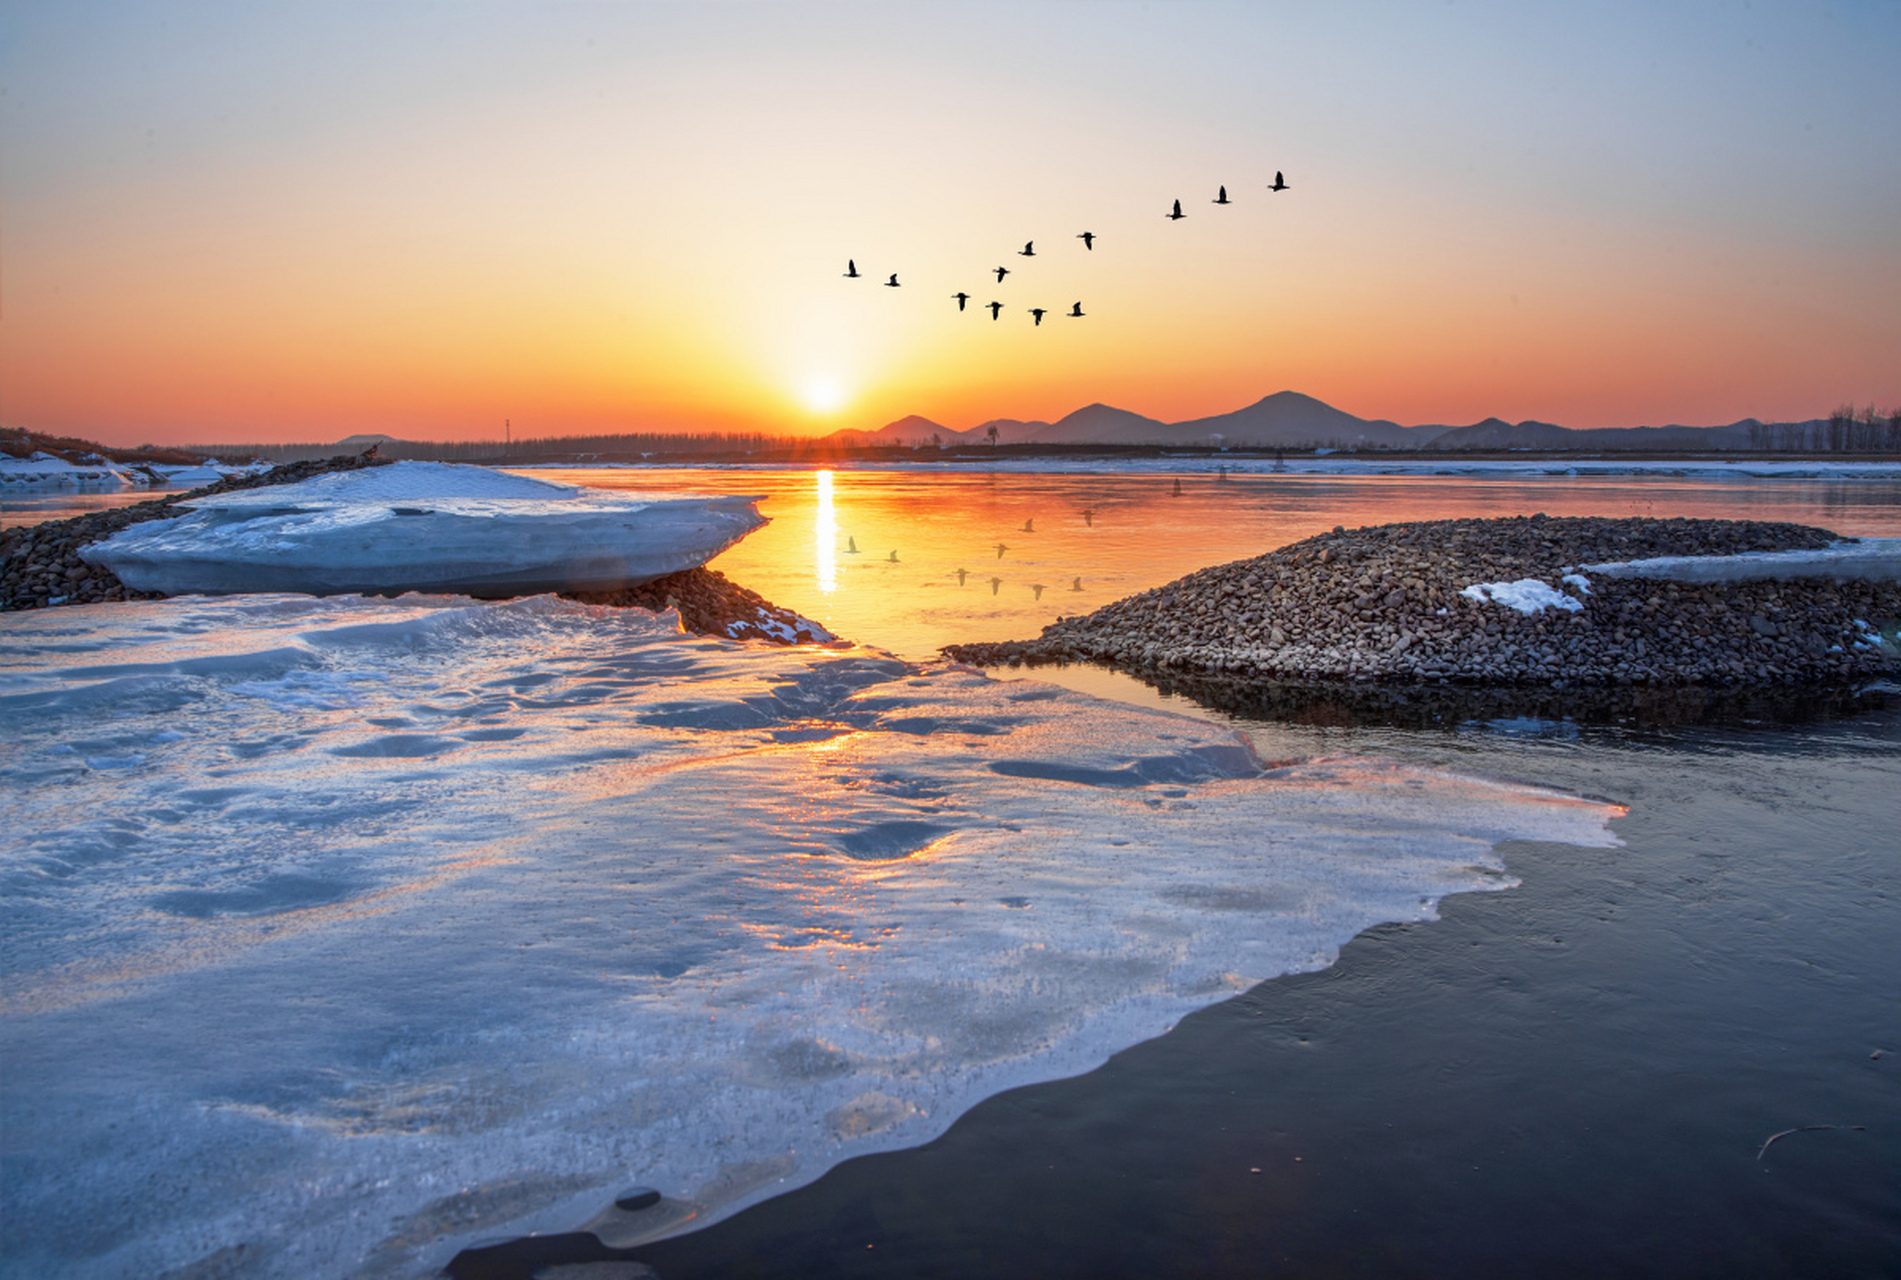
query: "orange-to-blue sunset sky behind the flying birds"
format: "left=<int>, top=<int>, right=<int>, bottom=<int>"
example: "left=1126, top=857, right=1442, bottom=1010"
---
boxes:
left=0, top=0, right=1901, bottom=443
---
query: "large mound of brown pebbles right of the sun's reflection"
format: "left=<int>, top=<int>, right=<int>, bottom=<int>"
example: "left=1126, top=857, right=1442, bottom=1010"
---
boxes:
left=945, top=515, right=1901, bottom=687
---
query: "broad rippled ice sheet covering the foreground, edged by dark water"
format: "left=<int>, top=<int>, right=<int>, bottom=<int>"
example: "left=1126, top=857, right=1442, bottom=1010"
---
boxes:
left=0, top=595, right=1618, bottom=1280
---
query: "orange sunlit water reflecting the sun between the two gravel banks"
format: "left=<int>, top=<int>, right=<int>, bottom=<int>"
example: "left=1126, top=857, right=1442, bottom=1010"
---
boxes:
left=536, top=468, right=1901, bottom=658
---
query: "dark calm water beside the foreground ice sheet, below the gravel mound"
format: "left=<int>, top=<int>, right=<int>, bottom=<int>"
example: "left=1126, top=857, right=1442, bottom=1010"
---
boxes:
left=637, top=698, right=1901, bottom=1280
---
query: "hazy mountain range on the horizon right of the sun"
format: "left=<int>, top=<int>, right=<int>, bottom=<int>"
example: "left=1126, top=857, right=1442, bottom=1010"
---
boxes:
left=825, top=392, right=1829, bottom=449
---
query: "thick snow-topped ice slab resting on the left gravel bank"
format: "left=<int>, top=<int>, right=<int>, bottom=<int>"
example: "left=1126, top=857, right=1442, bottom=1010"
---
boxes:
left=80, top=462, right=766, bottom=597
